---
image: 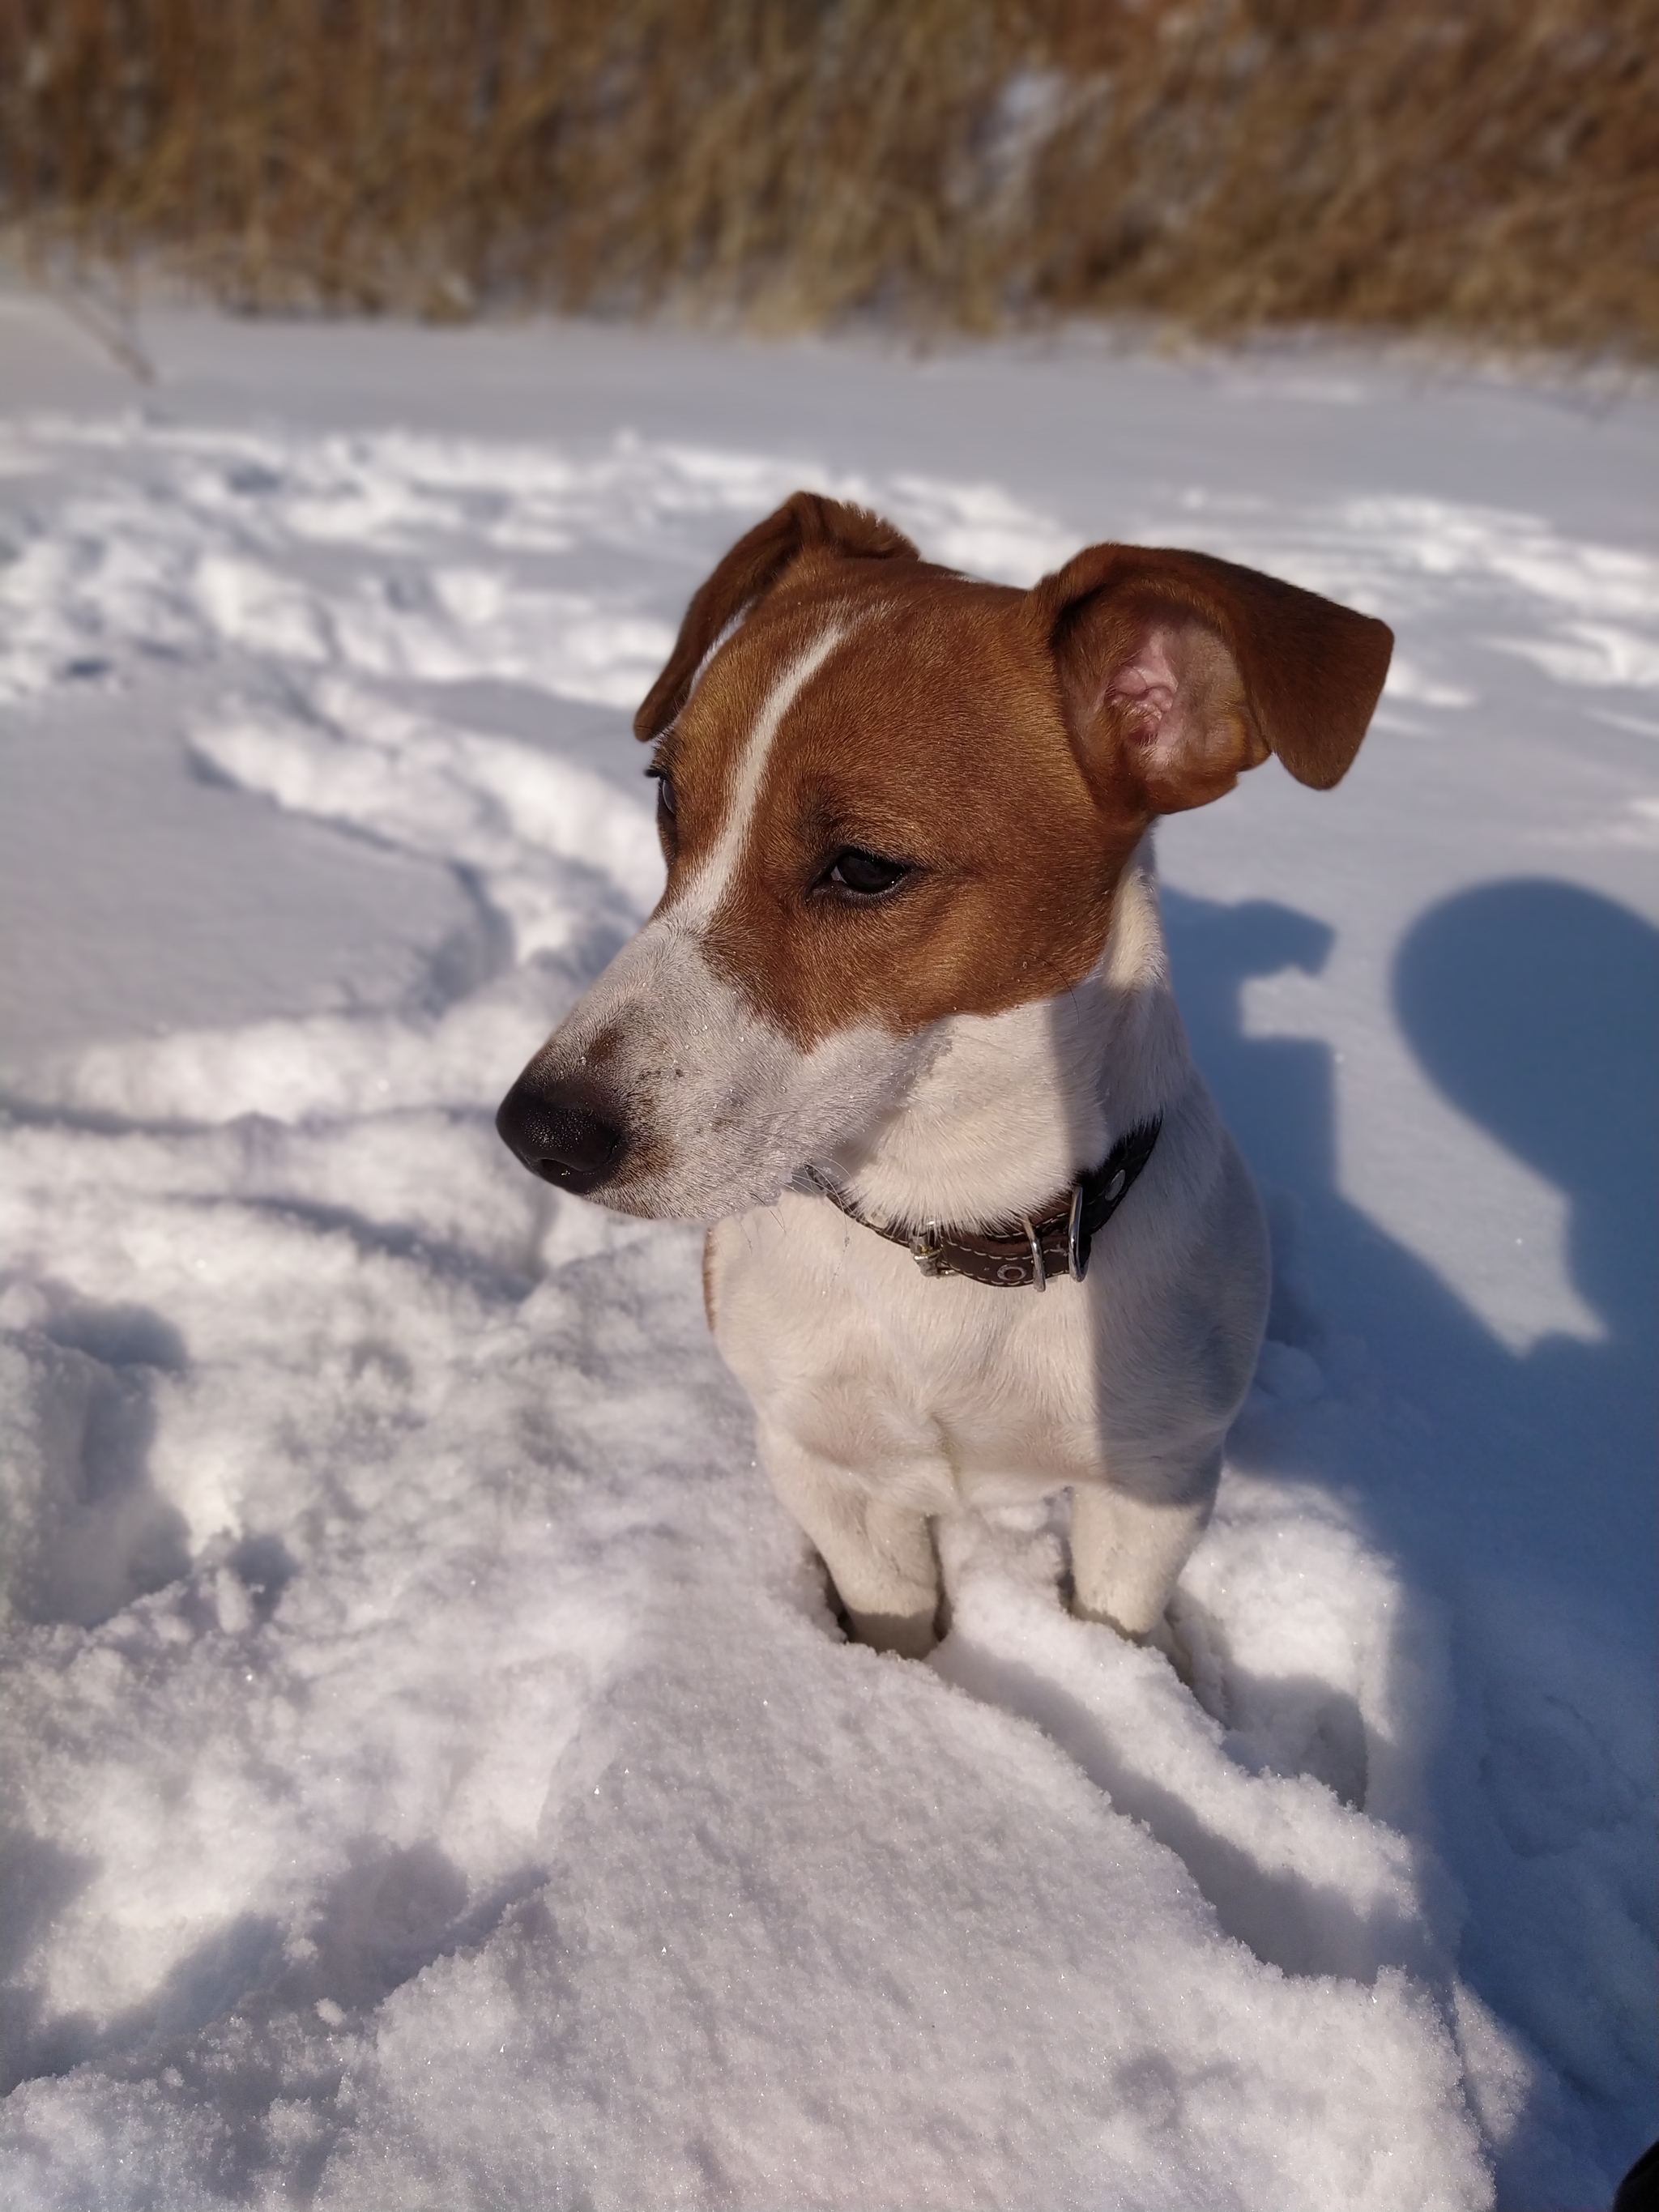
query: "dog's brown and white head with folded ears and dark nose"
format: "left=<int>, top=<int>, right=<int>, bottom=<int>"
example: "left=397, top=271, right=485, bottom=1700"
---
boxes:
left=497, top=491, right=1392, bottom=1221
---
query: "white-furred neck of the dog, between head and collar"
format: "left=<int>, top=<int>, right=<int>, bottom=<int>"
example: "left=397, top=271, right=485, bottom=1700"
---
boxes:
left=841, top=836, right=1192, bottom=1228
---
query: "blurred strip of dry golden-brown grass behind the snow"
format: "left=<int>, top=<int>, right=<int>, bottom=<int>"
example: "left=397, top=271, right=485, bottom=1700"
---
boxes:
left=0, top=0, right=1659, bottom=358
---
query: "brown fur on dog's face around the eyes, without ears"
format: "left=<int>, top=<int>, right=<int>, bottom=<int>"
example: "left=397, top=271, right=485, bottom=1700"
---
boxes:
left=666, top=564, right=1148, bottom=1048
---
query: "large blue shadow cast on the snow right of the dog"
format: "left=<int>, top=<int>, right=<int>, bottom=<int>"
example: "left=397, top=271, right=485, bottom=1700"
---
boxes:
left=1163, top=880, right=1659, bottom=2194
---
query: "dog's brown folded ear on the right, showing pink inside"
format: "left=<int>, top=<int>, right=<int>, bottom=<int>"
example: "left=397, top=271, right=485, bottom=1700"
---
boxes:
left=1030, top=547, right=1393, bottom=814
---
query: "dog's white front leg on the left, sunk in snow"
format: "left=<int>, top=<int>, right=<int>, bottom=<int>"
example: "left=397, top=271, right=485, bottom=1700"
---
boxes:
left=761, top=1429, right=938, bottom=1659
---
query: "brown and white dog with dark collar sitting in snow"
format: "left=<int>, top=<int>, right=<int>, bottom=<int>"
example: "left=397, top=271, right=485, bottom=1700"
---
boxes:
left=497, top=493, right=1392, bottom=1652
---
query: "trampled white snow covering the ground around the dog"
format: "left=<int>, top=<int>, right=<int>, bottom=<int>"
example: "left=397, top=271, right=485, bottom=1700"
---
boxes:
left=0, top=296, right=1659, bottom=2212
